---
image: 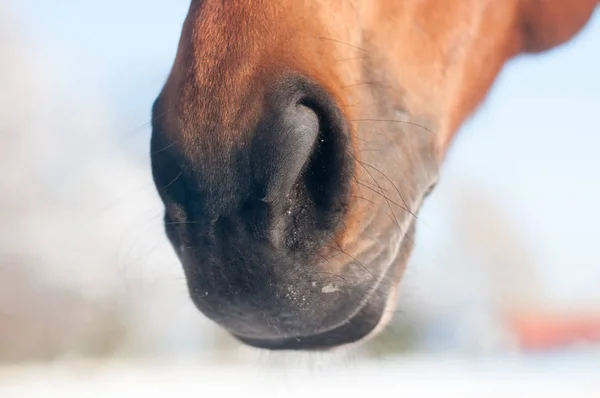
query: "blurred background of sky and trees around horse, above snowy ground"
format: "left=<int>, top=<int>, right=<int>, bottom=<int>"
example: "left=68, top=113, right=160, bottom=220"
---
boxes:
left=0, top=0, right=600, bottom=396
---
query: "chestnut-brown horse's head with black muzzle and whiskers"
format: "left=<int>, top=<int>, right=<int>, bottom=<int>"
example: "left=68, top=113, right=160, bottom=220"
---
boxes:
left=151, top=0, right=598, bottom=350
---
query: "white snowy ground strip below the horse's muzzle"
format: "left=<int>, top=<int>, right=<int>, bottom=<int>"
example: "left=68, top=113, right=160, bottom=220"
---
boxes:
left=0, top=357, right=600, bottom=398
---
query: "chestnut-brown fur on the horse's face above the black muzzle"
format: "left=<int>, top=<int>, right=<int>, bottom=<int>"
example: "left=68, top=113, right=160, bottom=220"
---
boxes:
left=165, top=0, right=597, bottom=258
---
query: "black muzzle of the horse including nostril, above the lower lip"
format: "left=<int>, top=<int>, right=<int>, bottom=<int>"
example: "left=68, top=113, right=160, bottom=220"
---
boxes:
left=152, top=78, right=366, bottom=344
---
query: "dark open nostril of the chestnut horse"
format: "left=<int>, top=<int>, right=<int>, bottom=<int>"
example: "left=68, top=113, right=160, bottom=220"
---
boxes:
left=252, top=80, right=352, bottom=247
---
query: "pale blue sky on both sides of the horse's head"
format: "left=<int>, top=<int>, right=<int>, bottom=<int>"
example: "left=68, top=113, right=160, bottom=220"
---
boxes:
left=8, top=0, right=600, bottom=299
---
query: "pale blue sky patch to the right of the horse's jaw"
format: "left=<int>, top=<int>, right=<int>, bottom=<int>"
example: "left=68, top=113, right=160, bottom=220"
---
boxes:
left=445, top=12, right=600, bottom=304
